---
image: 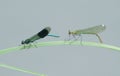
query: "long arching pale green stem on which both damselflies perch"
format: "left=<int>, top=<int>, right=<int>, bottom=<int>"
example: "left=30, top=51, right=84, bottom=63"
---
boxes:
left=0, top=41, right=120, bottom=55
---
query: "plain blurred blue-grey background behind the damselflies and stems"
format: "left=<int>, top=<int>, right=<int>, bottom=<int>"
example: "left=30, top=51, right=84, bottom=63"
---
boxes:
left=0, top=0, right=120, bottom=76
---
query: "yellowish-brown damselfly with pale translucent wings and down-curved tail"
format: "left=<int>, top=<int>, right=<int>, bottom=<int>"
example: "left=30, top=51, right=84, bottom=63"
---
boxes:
left=68, top=25, right=106, bottom=43
